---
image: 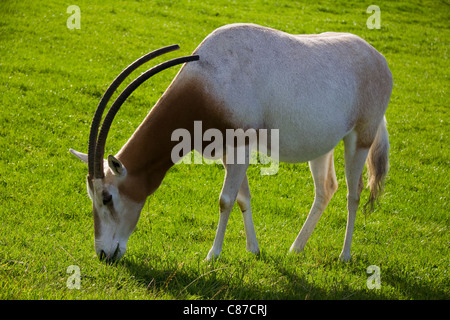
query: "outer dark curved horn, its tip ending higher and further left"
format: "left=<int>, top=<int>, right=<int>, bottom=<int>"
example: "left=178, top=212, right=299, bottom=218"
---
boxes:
left=88, top=44, right=180, bottom=179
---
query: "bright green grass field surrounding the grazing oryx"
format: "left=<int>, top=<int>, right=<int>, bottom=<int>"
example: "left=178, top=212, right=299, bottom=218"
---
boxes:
left=0, top=0, right=450, bottom=299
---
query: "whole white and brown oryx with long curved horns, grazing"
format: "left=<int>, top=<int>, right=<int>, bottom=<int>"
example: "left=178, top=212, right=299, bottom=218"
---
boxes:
left=71, top=24, right=392, bottom=260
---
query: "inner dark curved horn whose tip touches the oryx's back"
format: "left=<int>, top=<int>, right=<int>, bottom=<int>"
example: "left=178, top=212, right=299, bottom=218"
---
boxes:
left=94, top=55, right=199, bottom=179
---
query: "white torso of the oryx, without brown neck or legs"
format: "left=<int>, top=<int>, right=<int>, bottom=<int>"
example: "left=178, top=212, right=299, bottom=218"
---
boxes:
left=185, top=24, right=392, bottom=162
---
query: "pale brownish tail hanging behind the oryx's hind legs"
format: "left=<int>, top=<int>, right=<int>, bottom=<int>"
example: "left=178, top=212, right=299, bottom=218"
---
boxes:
left=364, top=118, right=389, bottom=211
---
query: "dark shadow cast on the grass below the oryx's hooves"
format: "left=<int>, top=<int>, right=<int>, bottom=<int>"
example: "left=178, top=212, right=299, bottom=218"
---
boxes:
left=119, top=254, right=398, bottom=300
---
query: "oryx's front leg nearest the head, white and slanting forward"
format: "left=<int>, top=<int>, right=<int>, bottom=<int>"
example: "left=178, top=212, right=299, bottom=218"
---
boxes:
left=206, top=159, right=248, bottom=260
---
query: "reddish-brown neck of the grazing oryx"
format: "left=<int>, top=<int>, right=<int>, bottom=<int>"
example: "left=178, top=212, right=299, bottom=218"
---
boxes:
left=117, top=77, right=231, bottom=201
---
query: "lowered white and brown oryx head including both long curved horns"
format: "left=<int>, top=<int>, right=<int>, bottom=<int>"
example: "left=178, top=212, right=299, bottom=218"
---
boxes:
left=70, top=45, right=198, bottom=261
